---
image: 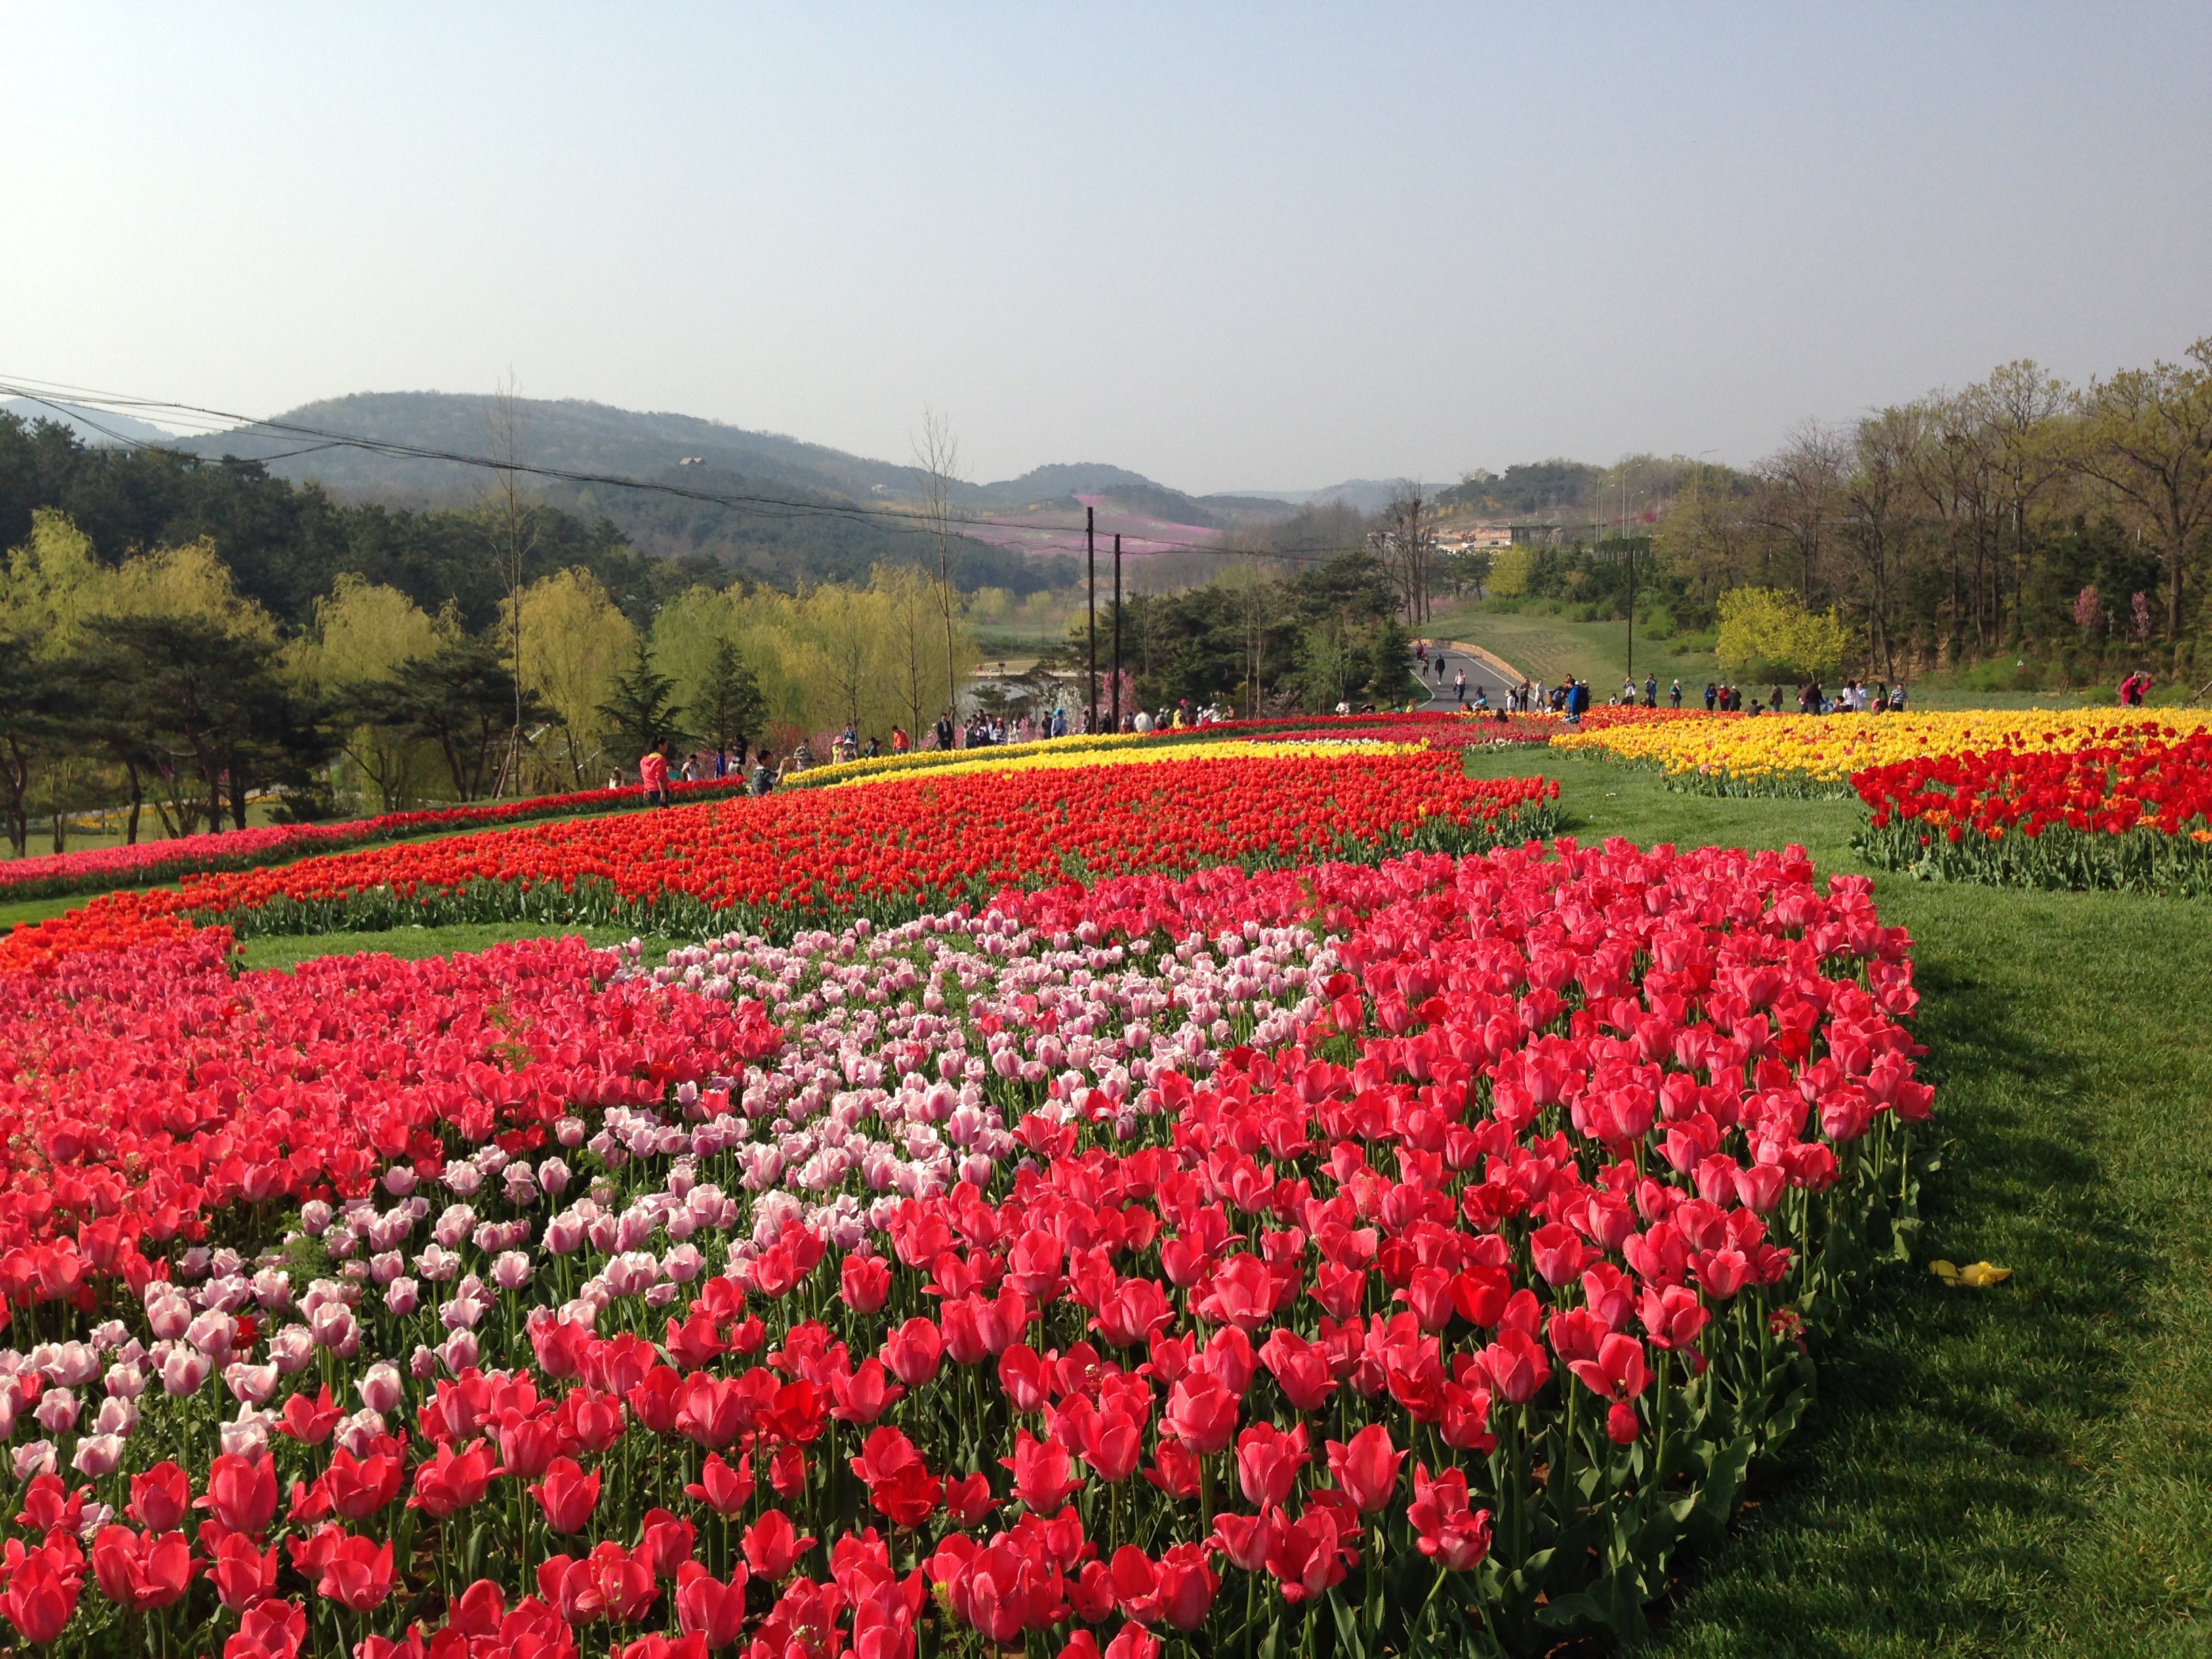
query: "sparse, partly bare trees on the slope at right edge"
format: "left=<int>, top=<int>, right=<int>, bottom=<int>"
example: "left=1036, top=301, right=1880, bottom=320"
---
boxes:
left=1447, top=338, right=2212, bottom=686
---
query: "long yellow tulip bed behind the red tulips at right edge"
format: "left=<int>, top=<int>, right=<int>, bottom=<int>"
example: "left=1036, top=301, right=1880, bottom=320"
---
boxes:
left=1551, top=708, right=2212, bottom=787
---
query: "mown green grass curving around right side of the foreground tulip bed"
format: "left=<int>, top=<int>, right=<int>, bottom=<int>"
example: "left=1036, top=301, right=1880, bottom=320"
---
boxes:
left=1471, top=752, right=2212, bottom=1659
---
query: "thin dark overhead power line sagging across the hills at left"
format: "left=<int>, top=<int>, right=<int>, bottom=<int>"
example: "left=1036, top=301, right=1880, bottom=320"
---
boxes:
left=0, top=378, right=1360, bottom=564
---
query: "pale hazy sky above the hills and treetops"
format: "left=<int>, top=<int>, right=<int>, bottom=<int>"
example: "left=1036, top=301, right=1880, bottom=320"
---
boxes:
left=0, top=0, right=2212, bottom=491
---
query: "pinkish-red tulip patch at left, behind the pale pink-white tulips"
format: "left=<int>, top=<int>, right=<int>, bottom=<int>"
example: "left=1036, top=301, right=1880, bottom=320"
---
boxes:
left=0, top=937, right=779, bottom=1330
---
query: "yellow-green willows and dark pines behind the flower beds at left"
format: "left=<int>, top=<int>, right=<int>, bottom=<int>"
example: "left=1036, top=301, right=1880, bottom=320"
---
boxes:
left=0, top=506, right=975, bottom=856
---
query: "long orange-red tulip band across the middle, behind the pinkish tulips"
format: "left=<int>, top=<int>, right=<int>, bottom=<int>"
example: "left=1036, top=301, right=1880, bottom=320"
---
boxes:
left=0, top=752, right=1559, bottom=973
